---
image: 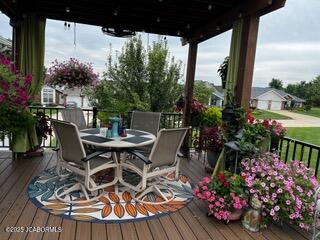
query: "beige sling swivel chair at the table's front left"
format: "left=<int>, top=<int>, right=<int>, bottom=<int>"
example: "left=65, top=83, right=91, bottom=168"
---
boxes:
left=51, top=120, right=118, bottom=203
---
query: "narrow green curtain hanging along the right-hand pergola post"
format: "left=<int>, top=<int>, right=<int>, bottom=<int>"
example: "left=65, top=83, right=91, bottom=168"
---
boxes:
left=212, top=19, right=243, bottom=176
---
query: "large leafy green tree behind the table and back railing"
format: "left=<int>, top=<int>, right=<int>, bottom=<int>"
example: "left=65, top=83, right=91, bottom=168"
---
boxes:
left=87, top=36, right=183, bottom=112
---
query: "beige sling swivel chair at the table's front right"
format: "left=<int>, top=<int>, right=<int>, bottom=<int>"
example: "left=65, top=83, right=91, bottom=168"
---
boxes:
left=119, top=128, right=190, bottom=204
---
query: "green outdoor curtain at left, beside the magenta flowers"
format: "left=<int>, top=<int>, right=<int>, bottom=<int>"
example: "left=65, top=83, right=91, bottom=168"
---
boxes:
left=11, top=14, right=46, bottom=152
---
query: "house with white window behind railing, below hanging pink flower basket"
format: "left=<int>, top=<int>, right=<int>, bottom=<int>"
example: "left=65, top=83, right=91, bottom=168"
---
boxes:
left=41, top=86, right=90, bottom=108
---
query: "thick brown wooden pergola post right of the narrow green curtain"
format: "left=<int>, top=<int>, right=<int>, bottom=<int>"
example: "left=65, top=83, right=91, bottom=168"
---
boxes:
left=235, top=15, right=260, bottom=110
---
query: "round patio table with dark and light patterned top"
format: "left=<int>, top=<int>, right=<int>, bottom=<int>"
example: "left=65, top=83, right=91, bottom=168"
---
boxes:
left=80, top=128, right=156, bottom=192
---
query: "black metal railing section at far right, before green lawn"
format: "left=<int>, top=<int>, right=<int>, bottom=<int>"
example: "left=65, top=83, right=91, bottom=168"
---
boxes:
left=278, top=137, right=320, bottom=176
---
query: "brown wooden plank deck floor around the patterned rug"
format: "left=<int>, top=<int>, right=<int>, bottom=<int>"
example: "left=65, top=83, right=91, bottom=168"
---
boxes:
left=0, top=151, right=307, bottom=240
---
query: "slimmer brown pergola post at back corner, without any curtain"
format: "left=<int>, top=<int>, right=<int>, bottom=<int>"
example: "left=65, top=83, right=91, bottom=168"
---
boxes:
left=182, top=43, right=198, bottom=156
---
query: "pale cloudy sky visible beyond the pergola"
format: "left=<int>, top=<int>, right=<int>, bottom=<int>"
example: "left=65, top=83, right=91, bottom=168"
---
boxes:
left=0, top=0, right=320, bottom=87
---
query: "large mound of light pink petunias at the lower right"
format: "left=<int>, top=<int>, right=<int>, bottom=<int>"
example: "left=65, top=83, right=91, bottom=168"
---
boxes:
left=241, top=154, right=319, bottom=230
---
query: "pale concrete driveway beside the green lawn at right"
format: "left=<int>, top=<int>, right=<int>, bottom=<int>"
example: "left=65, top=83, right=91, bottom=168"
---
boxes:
left=270, top=110, right=320, bottom=127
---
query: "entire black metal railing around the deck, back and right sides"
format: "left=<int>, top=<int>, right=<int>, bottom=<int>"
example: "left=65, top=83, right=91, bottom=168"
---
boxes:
left=0, top=106, right=320, bottom=176
